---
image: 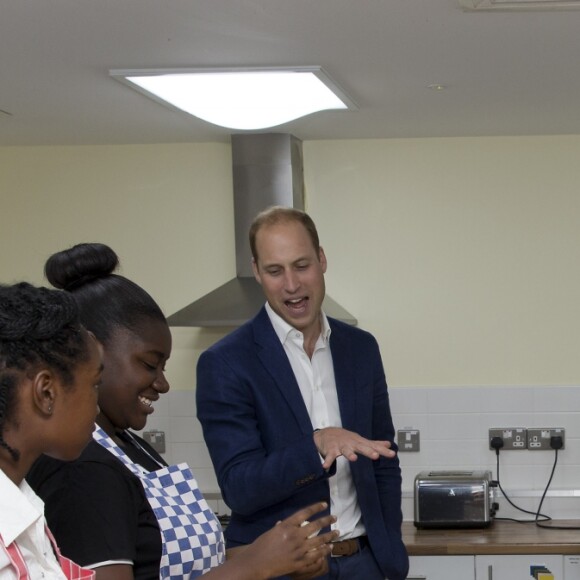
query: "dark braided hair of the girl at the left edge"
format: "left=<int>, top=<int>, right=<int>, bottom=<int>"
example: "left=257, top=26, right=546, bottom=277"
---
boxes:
left=0, top=282, right=89, bottom=461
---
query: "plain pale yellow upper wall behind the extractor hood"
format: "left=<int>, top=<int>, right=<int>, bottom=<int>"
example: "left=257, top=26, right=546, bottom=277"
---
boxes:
left=0, top=136, right=580, bottom=389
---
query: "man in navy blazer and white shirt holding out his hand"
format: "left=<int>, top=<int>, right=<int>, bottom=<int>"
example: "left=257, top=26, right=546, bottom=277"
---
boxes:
left=197, top=207, right=408, bottom=580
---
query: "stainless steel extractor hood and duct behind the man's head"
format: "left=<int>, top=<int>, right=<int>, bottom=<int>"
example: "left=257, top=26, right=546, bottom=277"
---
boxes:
left=167, top=133, right=357, bottom=326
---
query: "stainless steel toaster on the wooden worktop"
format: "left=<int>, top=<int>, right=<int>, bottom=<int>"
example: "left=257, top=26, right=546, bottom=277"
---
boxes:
left=414, top=471, right=498, bottom=528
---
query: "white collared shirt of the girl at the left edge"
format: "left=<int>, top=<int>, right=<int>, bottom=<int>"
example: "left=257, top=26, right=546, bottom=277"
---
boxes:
left=0, top=470, right=66, bottom=580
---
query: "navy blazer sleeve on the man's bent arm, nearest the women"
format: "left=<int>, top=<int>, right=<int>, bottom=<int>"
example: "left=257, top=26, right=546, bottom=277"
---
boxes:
left=196, top=349, right=335, bottom=515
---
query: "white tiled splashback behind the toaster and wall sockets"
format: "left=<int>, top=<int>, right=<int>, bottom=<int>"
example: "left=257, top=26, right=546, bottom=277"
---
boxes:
left=135, top=386, right=580, bottom=520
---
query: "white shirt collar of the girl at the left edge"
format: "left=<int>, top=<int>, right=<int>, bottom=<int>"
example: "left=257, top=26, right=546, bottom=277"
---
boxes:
left=0, top=469, right=44, bottom=545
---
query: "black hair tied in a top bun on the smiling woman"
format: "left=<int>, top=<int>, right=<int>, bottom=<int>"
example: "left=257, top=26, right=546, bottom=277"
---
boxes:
left=44, top=243, right=166, bottom=345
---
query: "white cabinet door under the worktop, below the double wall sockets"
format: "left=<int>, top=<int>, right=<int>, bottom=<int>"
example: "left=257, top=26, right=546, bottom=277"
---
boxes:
left=475, top=554, right=567, bottom=580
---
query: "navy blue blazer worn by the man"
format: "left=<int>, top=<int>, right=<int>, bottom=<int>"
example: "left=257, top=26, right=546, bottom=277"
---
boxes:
left=196, top=308, right=408, bottom=580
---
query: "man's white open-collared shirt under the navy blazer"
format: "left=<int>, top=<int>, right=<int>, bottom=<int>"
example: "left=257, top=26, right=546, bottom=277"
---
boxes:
left=266, top=303, right=366, bottom=540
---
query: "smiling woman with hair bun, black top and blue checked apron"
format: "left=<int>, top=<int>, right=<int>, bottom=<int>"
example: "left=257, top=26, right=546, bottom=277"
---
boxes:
left=29, top=244, right=336, bottom=580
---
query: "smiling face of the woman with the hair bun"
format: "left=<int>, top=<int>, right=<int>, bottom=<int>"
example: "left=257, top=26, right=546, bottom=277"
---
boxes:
left=97, top=318, right=171, bottom=431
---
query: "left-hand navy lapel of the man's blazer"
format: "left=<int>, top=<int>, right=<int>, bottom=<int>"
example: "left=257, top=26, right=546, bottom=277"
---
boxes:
left=252, top=308, right=312, bottom=434
